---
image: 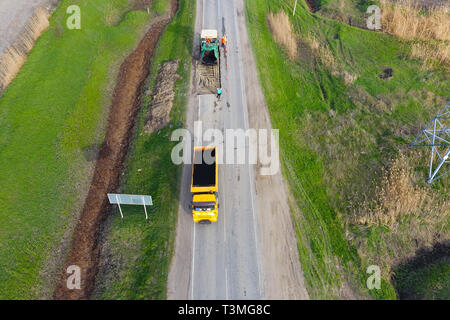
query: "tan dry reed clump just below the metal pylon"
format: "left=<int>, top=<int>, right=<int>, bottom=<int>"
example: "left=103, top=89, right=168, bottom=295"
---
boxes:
left=352, top=155, right=450, bottom=228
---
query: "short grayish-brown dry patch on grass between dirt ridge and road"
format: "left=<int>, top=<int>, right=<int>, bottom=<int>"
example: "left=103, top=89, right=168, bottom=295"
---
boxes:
left=144, top=60, right=179, bottom=134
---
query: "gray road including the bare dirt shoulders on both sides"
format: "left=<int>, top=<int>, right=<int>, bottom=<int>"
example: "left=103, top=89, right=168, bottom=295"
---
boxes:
left=167, top=0, right=308, bottom=299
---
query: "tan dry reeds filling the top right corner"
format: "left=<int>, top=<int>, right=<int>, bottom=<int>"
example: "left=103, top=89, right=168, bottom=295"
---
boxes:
left=380, top=0, right=450, bottom=40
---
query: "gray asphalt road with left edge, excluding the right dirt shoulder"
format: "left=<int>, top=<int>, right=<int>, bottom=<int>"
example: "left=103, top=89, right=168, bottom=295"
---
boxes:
left=168, top=0, right=264, bottom=300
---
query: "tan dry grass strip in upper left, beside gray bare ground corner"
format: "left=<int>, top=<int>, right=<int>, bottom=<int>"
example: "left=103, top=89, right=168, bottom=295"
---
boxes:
left=0, top=8, right=49, bottom=90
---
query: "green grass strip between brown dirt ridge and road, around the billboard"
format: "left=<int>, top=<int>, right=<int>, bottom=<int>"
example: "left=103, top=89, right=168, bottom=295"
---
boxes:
left=94, top=0, right=195, bottom=299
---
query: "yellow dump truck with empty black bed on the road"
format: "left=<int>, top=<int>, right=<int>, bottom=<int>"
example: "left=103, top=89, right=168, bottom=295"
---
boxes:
left=191, top=147, right=219, bottom=223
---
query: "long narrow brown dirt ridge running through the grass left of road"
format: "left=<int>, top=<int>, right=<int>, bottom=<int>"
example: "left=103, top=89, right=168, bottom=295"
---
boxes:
left=53, top=0, right=178, bottom=299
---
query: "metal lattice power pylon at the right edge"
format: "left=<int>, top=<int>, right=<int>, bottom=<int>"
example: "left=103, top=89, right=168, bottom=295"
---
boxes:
left=411, top=101, right=450, bottom=183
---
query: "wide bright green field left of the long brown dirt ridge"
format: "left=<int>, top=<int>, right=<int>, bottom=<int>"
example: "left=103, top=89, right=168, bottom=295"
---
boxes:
left=0, top=0, right=160, bottom=299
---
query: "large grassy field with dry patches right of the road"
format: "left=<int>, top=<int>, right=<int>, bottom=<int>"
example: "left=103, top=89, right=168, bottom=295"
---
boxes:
left=246, top=0, right=450, bottom=299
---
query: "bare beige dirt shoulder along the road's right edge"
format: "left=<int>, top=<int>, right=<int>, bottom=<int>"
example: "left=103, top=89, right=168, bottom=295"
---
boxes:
left=237, top=0, right=309, bottom=299
